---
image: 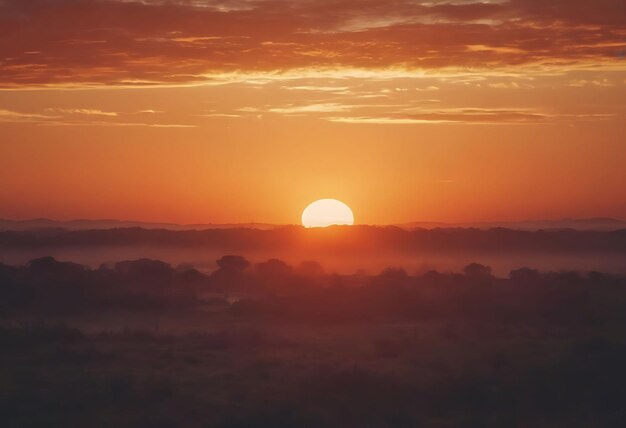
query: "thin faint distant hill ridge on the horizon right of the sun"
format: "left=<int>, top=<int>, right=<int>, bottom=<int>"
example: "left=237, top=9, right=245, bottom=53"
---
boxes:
left=397, top=218, right=626, bottom=231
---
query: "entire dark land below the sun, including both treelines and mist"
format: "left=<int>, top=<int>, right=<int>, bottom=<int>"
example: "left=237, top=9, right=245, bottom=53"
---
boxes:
left=0, top=221, right=626, bottom=428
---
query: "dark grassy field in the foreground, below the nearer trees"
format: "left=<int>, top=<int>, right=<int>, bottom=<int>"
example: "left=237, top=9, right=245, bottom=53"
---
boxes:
left=0, top=316, right=626, bottom=427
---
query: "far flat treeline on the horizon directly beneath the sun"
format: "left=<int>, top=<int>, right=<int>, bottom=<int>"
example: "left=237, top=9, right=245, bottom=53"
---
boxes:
left=0, top=226, right=626, bottom=254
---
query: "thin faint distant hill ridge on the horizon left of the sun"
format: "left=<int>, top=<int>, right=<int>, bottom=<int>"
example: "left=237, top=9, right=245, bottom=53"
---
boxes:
left=0, top=218, right=276, bottom=230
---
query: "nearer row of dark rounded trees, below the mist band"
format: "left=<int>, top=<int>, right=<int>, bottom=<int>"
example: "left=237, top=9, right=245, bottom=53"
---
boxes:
left=0, top=256, right=626, bottom=323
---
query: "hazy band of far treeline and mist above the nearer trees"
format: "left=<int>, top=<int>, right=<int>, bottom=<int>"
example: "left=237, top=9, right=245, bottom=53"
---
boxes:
left=0, top=227, right=626, bottom=275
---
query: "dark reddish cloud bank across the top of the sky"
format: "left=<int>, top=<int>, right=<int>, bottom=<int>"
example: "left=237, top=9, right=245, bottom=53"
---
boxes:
left=0, top=0, right=626, bottom=88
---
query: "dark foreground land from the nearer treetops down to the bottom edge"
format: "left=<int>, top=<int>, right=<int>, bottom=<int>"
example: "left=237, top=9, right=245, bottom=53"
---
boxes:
left=0, top=258, right=626, bottom=428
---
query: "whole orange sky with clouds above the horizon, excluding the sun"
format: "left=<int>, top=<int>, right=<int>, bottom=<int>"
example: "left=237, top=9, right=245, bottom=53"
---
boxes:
left=0, top=0, right=626, bottom=224
